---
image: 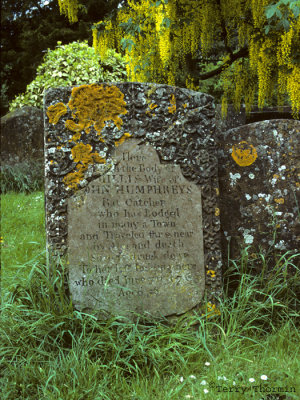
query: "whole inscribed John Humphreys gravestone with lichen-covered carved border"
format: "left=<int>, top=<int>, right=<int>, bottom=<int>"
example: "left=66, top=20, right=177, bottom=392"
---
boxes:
left=45, top=83, right=221, bottom=318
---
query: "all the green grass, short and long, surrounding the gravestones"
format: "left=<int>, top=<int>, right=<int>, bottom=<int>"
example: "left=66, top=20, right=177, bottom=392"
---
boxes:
left=0, top=192, right=300, bottom=400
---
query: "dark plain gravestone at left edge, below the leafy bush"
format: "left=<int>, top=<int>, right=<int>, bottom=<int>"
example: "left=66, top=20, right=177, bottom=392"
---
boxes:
left=1, top=107, right=44, bottom=164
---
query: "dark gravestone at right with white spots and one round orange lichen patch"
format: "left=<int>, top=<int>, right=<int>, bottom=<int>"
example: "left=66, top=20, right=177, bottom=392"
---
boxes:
left=218, top=120, right=300, bottom=259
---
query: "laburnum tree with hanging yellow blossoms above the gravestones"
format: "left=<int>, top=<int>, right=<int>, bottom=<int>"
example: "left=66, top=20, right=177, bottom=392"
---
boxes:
left=58, top=0, right=300, bottom=116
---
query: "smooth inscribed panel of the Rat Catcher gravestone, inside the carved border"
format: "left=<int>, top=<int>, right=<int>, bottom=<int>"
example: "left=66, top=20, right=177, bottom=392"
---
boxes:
left=68, top=139, right=205, bottom=316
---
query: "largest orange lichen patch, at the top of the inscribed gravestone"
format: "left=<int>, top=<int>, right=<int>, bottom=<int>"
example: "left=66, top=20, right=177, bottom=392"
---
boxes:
left=68, top=84, right=127, bottom=134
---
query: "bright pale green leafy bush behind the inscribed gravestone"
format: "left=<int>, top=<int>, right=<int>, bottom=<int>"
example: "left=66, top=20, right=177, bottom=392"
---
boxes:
left=9, top=42, right=126, bottom=111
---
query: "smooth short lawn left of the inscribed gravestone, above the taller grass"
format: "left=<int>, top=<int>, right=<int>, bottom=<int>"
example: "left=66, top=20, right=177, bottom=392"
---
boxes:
left=1, top=192, right=46, bottom=291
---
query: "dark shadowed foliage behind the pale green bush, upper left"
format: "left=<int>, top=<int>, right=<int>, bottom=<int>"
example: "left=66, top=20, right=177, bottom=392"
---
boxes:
left=0, top=0, right=123, bottom=115
